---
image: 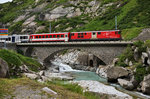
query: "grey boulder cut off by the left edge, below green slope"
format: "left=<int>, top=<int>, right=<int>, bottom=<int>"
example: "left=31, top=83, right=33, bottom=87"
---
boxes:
left=0, top=58, right=9, bottom=78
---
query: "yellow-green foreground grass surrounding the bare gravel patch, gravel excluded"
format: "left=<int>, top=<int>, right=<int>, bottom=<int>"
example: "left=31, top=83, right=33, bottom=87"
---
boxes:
left=0, top=77, right=104, bottom=99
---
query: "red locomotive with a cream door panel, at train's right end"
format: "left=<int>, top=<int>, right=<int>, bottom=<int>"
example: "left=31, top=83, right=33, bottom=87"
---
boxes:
left=70, top=30, right=121, bottom=41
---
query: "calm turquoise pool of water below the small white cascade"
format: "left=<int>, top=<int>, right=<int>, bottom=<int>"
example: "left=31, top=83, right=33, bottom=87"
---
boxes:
left=71, top=71, right=107, bottom=83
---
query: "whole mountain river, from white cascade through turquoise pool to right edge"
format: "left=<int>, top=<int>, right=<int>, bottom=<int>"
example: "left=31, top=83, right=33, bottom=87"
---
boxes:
left=49, top=62, right=150, bottom=99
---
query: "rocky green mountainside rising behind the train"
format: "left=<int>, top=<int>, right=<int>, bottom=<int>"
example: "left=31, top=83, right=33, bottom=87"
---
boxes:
left=0, top=0, right=150, bottom=40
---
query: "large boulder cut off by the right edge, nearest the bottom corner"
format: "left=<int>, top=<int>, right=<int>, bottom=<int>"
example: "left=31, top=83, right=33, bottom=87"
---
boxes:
left=141, top=74, right=150, bottom=95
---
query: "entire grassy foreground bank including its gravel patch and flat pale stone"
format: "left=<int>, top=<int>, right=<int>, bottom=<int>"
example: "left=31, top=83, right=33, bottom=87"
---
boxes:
left=0, top=77, right=102, bottom=99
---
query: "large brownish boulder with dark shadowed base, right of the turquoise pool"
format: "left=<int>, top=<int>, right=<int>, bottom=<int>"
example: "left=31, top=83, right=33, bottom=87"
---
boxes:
left=106, top=67, right=129, bottom=82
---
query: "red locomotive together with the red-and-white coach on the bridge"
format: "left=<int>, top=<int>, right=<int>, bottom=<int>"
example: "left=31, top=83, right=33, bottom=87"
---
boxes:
left=29, top=30, right=121, bottom=42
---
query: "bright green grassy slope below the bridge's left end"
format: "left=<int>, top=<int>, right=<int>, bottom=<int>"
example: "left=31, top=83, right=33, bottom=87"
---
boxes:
left=0, top=49, right=41, bottom=71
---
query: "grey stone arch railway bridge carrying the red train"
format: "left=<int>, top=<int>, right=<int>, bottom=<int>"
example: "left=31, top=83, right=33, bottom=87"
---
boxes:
left=17, top=41, right=133, bottom=65
